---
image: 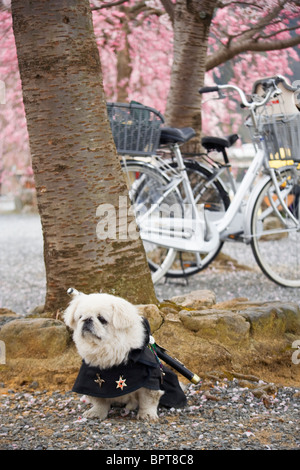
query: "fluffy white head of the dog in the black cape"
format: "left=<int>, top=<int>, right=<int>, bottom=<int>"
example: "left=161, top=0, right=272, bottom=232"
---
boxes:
left=64, top=291, right=144, bottom=368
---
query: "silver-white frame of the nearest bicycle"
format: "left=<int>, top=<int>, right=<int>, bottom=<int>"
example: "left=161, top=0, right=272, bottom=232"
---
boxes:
left=138, top=144, right=264, bottom=253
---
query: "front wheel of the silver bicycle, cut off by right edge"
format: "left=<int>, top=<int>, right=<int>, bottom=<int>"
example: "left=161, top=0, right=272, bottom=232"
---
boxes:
left=251, top=167, right=300, bottom=287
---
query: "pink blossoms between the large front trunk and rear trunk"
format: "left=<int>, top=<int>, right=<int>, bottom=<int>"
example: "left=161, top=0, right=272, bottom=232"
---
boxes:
left=92, top=0, right=173, bottom=108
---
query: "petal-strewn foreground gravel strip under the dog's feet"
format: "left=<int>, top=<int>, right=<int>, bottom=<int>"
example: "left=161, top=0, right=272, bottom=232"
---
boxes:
left=0, top=377, right=300, bottom=455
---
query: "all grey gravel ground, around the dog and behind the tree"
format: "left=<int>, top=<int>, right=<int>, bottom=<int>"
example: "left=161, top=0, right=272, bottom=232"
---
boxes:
left=0, top=214, right=300, bottom=452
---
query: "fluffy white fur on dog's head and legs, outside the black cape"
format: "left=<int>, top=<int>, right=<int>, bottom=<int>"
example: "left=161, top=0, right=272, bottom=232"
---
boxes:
left=64, top=291, right=163, bottom=421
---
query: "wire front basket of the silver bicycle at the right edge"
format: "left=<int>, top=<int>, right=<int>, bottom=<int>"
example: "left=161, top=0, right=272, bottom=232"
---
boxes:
left=260, top=113, right=300, bottom=163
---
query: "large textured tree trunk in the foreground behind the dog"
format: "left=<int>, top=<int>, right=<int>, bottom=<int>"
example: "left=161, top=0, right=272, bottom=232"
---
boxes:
left=12, top=0, right=156, bottom=312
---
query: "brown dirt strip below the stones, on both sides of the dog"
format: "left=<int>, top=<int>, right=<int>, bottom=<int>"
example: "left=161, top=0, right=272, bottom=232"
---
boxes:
left=0, top=338, right=300, bottom=394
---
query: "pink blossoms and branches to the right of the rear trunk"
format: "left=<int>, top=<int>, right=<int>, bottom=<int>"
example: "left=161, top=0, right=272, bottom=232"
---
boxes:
left=203, top=0, right=300, bottom=139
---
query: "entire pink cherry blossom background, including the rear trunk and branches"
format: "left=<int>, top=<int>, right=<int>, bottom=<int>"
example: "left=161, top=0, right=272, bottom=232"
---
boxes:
left=0, top=0, right=300, bottom=189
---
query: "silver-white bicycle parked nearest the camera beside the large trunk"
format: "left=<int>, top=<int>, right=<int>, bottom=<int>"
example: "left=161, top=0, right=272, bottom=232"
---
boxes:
left=106, top=76, right=300, bottom=287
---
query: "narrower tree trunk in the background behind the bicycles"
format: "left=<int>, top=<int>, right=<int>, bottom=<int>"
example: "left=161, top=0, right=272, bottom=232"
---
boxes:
left=165, top=0, right=217, bottom=152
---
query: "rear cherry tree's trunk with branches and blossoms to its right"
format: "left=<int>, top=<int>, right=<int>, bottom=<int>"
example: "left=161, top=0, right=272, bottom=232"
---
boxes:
left=164, top=0, right=300, bottom=150
